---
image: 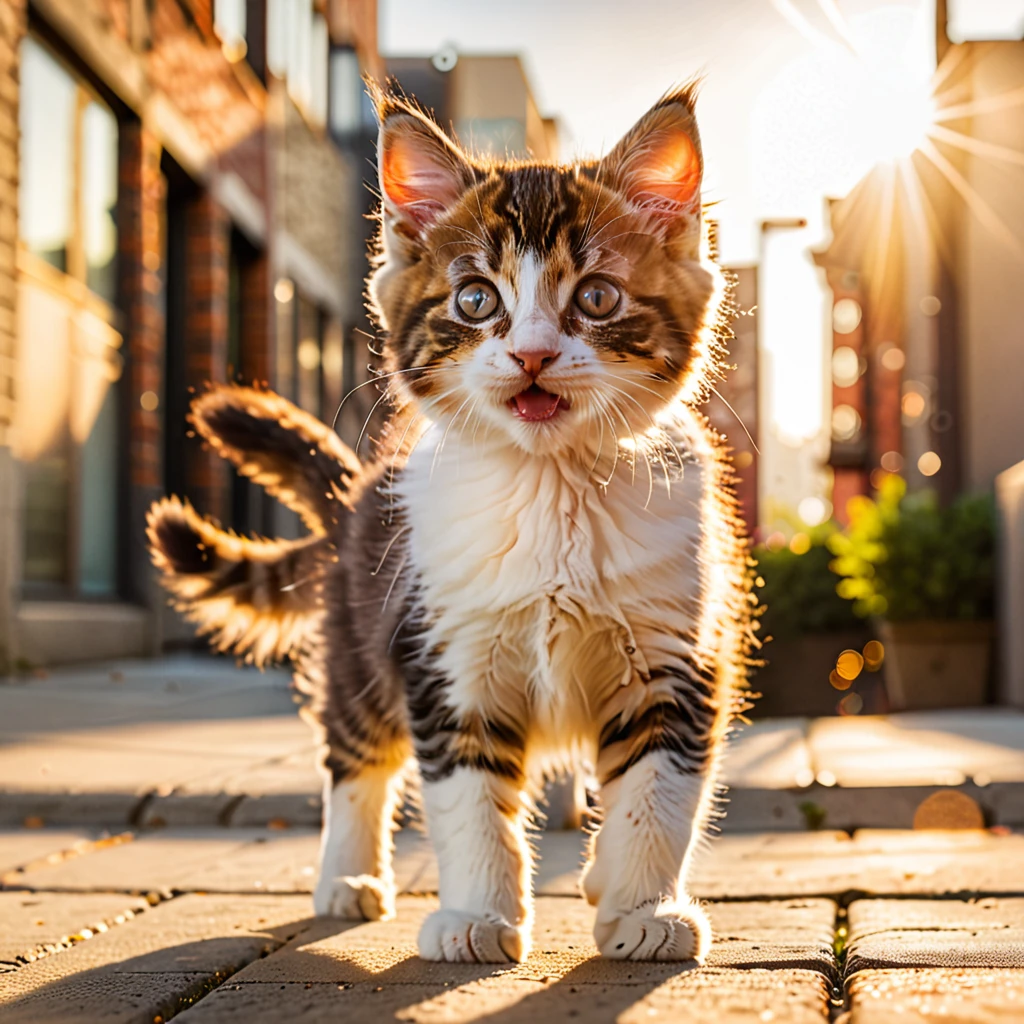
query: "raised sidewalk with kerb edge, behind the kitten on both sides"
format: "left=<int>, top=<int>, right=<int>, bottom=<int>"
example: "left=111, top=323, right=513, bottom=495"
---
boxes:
left=0, top=655, right=1024, bottom=831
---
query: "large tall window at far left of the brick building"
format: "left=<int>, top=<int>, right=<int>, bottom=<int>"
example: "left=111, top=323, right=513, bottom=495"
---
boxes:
left=15, top=37, right=122, bottom=597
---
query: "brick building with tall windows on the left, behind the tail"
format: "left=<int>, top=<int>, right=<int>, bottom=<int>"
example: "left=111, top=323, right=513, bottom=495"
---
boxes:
left=0, top=0, right=380, bottom=666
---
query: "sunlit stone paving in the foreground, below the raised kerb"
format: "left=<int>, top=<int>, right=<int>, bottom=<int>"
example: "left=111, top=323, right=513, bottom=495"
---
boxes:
left=0, top=828, right=1024, bottom=1024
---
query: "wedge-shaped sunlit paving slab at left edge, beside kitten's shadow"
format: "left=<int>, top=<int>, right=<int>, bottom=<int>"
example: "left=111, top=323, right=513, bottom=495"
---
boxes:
left=0, top=892, right=148, bottom=973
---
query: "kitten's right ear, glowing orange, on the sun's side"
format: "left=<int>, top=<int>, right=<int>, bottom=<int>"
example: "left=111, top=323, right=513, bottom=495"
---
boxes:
left=602, top=85, right=703, bottom=218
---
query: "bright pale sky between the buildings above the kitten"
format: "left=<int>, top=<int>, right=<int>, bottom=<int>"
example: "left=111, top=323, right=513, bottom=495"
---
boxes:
left=380, top=0, right=937, bottom=263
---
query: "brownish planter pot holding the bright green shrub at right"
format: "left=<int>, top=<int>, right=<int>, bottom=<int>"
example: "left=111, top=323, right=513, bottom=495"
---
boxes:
left=879, top=622, right=995, bottom=711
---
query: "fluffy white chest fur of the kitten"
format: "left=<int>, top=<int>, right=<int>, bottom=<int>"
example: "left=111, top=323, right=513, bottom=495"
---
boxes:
left=399, top=437, right=700, bottom=729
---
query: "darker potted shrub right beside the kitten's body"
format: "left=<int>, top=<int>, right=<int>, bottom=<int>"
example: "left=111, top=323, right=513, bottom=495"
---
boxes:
left=751, top=523, right=868, bottom=717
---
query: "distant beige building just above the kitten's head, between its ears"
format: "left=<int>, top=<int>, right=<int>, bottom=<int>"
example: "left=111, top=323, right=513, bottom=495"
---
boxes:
left=387, top=49, right=558, bottom=160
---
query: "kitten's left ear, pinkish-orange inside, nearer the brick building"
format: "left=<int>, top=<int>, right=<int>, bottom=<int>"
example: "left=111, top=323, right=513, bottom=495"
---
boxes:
left=377, top=93, right=473, bottom=234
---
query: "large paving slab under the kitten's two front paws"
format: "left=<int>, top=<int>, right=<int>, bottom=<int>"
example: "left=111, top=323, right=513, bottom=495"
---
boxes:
left=172, top=896, right=836, bottom=1022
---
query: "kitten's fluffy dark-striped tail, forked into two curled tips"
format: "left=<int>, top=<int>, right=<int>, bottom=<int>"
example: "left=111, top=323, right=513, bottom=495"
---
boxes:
left=146, top=386, right=361, bottom=665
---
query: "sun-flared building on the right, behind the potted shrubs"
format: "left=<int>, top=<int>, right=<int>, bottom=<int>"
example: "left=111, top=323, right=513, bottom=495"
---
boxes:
left=816, top=2, right=1024, bottom=513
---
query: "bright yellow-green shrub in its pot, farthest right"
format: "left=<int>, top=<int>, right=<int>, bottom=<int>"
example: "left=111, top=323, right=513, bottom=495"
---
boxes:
left=828, top=476, right=995, bottom=710
